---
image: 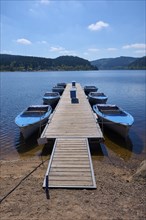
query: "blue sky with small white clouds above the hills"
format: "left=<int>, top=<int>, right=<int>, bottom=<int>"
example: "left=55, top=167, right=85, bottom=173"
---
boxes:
left=0, top=0, right=146, bottom=60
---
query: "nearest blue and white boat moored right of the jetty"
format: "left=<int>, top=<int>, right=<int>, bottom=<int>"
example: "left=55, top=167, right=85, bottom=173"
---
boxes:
left=93, top=104, right=134, bottom=138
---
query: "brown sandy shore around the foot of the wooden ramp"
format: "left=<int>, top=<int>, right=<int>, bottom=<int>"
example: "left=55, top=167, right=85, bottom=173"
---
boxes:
left=0, top=152, right=146, bottom=220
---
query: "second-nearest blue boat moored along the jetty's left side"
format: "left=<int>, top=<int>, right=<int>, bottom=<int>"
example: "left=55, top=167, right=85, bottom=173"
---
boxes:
left=43, top=92, right=60, bottom=107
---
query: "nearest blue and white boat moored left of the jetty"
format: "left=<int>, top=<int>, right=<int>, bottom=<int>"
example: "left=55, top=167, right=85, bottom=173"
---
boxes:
left=15, top=105, right=52, bottom=138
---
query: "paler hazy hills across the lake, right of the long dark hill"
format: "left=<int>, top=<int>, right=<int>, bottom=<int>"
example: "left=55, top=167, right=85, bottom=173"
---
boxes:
left=91, top=56, right=145, bottom=70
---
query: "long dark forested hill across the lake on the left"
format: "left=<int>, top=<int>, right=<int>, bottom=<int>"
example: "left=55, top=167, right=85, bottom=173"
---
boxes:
left=0, top=54, right=98, bottom=71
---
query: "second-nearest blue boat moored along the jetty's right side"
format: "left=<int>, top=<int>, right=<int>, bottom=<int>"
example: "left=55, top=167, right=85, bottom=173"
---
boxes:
left=88, top=92, right=108, bottom=105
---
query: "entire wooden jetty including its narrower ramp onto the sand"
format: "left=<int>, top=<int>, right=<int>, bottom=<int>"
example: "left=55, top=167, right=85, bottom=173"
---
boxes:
left=40, top=84, right=104, bottom=188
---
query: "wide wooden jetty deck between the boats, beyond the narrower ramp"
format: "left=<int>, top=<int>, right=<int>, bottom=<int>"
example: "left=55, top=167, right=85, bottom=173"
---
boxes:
left=41, top=84, right=103, bottom=138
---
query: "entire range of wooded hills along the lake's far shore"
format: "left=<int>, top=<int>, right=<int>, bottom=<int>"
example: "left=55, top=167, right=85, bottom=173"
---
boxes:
left=0, top=54, right=146, bottom=71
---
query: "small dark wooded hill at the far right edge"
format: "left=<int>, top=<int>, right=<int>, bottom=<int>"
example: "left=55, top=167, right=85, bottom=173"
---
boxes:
left=128, top=56, right=146, bottom=70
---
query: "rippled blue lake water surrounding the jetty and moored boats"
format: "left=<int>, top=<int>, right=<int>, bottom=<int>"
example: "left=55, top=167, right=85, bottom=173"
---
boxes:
left=0, top=70, right=146, bottom=160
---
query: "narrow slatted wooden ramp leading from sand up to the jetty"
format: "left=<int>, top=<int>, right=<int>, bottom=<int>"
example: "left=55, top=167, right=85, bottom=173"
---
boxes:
left=43, top=138, right=96, bottom=189
